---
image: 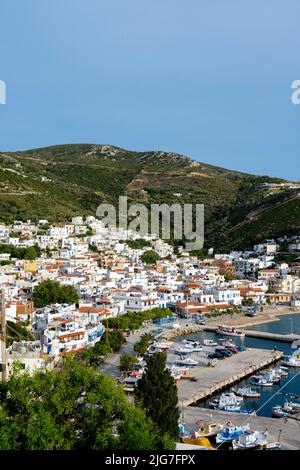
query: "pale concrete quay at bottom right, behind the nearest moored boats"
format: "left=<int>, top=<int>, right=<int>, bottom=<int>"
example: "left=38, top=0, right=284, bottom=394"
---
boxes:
left=182, top=406, right=300, bottom=450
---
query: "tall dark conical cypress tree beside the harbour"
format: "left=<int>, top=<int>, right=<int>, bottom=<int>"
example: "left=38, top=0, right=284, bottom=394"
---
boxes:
left=135, top=353, right=179, bottom=439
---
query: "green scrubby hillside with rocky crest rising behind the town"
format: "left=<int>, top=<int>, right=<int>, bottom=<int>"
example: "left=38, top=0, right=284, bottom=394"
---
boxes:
left=0, top=144, right=300, bottom=252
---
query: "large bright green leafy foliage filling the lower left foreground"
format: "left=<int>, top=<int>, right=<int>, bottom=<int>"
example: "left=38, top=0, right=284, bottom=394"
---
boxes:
left=0, top=359, right=175, bottom=450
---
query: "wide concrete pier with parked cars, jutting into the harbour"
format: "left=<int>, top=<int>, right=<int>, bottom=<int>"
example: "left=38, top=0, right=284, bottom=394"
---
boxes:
left=177, top=348, right=283, bottom=406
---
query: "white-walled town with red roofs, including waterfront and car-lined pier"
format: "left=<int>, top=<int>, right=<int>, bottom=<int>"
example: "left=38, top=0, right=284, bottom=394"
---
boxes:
left=0, top=216, right=300, bottom=448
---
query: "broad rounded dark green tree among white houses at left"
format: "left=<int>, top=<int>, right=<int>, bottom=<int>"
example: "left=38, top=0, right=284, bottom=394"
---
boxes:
left=32, top=279, right=79, bottom=308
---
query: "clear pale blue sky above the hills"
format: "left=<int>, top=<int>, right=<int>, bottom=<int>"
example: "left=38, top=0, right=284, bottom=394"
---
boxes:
left=0, top=0, right=300, bottom=180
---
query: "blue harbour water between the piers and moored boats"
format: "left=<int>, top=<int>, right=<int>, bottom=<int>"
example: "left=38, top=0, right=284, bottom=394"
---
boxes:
left=172, top=314, right=300, bottom=416
